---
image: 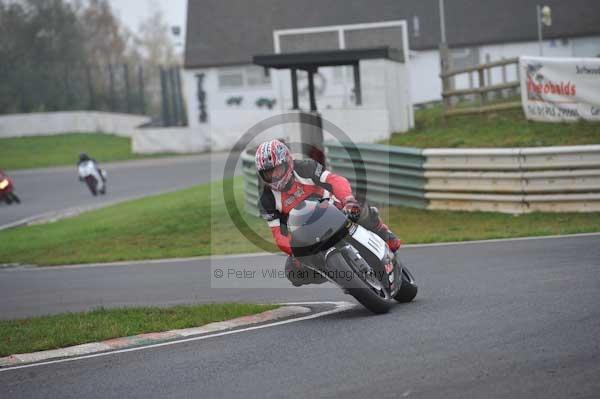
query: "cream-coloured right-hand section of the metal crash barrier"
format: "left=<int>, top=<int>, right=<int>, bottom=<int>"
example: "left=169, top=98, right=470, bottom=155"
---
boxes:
left=423, top=145, right=600, bottom=213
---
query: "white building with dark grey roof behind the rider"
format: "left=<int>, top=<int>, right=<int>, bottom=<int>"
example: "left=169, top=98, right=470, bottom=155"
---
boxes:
left=183, top=0, right=600, bottom=149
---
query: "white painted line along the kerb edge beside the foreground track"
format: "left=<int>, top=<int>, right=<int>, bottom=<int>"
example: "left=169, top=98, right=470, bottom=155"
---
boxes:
left=0, top=302, right=357, bottom=373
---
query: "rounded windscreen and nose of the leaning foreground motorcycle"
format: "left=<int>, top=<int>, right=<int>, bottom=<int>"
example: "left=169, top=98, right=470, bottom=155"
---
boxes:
left=287, top=201, right=348, bottom=256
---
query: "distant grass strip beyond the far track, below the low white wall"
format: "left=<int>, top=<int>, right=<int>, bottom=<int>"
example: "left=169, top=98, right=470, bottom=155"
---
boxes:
left=0, top=133, right=183, bottom=170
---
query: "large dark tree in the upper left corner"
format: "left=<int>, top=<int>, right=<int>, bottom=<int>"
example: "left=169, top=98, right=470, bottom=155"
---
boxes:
left=0, top=0, right=85, bottom=113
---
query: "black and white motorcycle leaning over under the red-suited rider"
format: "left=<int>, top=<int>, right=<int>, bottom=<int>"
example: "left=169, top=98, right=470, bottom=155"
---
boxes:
left=287, top=199, right=418, bottom=313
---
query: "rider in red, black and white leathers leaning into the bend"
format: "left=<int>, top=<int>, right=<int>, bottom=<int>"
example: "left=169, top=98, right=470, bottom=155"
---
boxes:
left=255, top=140, right=401, bottom=286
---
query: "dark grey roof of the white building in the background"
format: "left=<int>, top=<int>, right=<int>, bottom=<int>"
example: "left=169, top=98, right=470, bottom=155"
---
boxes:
left=185, top=0, right=600, bottom=68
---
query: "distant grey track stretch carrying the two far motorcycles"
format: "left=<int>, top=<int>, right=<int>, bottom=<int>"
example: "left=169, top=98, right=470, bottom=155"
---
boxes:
left=0, top=153, right=228, bottom=227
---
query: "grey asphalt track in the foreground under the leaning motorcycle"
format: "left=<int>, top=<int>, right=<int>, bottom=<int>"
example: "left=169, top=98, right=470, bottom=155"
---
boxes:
left=0, top=235, right=600, bottom=398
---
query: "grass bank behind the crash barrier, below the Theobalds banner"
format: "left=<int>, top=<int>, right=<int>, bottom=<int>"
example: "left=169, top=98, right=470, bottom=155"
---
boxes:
left=385, top=106, right=600, bottom=148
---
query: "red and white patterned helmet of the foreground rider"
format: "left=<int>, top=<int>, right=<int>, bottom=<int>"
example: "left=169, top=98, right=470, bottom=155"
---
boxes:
left=255, top=140, right=294, bottom=191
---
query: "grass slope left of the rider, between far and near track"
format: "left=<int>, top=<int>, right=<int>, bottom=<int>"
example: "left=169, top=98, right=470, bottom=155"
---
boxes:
left=0, top=178, right=270, bottom=265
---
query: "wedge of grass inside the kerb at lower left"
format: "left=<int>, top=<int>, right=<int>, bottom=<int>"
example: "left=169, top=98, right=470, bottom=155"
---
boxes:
left=0, top=303, right=279, bottom=356
